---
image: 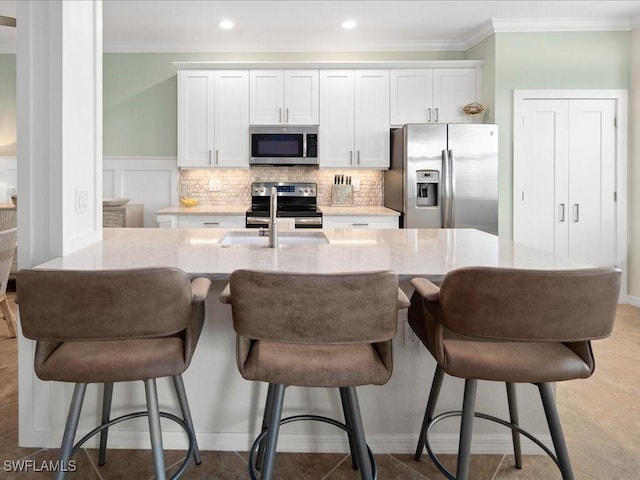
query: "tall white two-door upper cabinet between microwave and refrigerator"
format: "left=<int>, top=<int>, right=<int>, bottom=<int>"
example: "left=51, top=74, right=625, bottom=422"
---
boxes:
left=318, top=70, right=389, bottom=168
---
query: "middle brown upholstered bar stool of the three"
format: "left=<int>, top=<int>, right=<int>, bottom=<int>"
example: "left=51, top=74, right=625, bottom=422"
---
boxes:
left=221, top=270, right=409, bottom=480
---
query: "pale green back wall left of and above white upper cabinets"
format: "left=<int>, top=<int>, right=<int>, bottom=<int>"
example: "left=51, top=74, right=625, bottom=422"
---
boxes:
left=103, top=52, right=464, bottom=157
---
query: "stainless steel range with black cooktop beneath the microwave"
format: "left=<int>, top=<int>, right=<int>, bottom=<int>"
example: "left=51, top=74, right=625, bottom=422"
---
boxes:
left=246, top=182, right=322, bottom=228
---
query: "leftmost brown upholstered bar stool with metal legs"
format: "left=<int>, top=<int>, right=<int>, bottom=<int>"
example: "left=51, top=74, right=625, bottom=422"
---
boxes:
left=16, top=267, right=211, bottom=479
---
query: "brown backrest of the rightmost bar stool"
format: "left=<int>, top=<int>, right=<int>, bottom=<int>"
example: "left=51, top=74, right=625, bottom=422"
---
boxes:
left=438, top=267, right=621, bottom=342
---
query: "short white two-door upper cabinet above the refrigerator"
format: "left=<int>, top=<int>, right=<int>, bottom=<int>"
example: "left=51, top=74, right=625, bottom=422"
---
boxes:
left=390, top=68, right=478, bottom=125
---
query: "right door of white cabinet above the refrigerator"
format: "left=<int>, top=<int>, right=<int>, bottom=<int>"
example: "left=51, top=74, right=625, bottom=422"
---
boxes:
left=432, top=68, right=476, bottom=123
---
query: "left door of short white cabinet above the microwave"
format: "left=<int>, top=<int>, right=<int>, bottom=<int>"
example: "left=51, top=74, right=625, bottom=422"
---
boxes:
left=249, top=70, right=284, bottom=125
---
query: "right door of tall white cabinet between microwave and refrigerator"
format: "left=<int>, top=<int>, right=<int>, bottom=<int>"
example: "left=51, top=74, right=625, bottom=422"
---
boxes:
left=354, top=70, right=389, bottom=168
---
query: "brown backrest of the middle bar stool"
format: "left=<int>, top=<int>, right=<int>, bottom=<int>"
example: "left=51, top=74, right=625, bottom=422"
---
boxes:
left=230, top=270, right=398, bottom=344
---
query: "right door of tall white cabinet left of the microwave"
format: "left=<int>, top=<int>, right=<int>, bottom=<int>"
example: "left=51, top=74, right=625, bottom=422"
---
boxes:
left=213, top=70, right=249, bottom=167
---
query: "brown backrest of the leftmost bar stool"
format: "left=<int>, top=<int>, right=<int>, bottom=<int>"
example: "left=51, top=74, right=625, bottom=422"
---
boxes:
left=16, top=267, right=192, bottom=342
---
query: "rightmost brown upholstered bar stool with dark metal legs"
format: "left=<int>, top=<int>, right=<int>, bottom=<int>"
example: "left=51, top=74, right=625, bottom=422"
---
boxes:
left=409, top=267, right=620, bottom=480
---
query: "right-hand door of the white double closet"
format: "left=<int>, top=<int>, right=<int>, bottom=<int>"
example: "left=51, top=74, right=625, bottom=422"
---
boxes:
left=568, top=99, right=616, bottom=266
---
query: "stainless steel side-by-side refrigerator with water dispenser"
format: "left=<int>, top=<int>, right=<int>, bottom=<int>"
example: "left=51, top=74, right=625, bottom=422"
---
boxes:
left=384, top=124, right=498, bottom=235
